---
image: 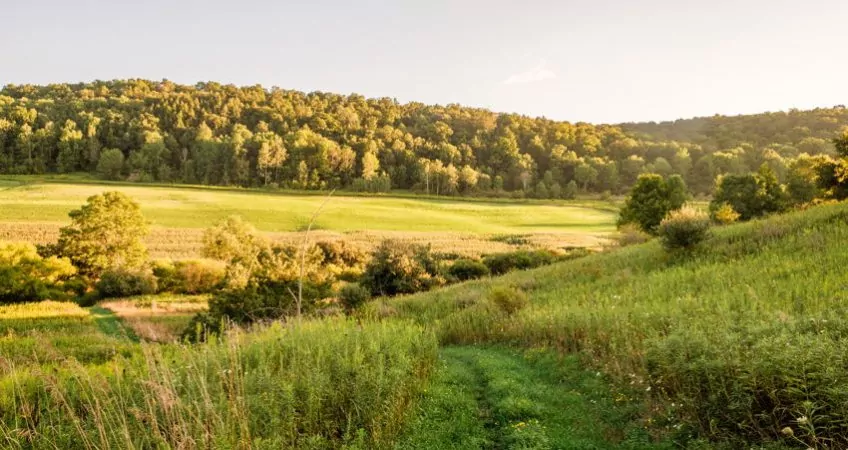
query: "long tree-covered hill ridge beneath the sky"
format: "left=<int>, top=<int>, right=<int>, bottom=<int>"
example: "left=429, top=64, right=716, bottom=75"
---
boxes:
left=0, top=80, right=848, bottom=198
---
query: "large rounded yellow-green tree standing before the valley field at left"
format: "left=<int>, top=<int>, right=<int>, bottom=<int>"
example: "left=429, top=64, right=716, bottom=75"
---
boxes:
left=57, top=192, right=147, bottom=278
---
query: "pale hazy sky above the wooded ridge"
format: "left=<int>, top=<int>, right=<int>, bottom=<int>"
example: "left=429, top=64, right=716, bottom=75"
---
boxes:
left=0, top=0, right=848, bottom=122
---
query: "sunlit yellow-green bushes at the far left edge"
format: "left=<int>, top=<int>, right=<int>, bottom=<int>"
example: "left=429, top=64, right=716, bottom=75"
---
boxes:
left=0, top=242, right=77, bottom=304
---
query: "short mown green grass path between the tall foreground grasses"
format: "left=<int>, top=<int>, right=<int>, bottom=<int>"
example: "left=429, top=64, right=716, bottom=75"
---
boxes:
left=397, top=347, right=671, bottom=450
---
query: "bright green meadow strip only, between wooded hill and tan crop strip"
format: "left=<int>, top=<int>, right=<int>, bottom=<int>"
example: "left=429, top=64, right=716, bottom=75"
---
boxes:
left=0, top=180, right=616, bottom=233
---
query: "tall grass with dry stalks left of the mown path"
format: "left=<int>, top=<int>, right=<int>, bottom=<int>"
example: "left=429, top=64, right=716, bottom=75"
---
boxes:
left=0, top=319, right=436, bottom=449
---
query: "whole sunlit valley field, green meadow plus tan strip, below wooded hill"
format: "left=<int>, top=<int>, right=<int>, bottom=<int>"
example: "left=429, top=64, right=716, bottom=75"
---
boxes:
left=0, top=179, right=616, bottom=258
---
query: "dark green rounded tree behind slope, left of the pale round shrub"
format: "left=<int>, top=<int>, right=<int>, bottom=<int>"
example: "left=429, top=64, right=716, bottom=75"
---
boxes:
left=618, top=174, right=687, bottom=234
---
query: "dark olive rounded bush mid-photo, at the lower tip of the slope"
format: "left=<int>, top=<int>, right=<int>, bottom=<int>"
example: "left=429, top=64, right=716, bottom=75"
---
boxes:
left=360, top=240, right=443, bottom=295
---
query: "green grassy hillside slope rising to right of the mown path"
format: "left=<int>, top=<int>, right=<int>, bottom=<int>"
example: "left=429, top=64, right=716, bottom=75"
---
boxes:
left=380, top=204, right=848, bottom=448
